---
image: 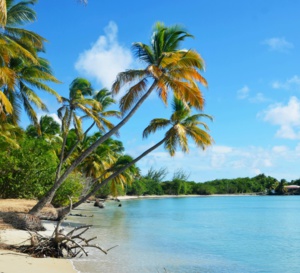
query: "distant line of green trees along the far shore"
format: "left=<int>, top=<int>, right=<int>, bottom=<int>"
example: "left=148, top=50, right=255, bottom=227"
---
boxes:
left=127, top=168, right=284, bottom=195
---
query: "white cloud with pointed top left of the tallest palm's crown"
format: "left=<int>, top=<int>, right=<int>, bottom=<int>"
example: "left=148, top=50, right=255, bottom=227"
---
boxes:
left=75, top=21, right=133, bottom=88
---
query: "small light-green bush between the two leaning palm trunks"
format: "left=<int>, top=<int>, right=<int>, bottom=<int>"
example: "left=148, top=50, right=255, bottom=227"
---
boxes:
left=52, top=174, right=85, bottom=207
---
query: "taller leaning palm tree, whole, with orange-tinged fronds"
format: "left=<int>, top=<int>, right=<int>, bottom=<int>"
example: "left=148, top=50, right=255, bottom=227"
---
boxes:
left=30, top=23, right=207, bottom=214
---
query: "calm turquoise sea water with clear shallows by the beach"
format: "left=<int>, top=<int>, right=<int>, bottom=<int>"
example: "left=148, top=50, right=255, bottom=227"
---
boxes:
left=69, top=196, right=300, bottom=273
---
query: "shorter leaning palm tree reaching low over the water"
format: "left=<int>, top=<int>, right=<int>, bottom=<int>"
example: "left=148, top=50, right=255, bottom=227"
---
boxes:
left=73, top=98, right=213, bottom=208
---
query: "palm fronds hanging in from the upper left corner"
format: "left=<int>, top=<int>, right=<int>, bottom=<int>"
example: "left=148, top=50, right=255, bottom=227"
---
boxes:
left=0, top=0, right=60, bottom=126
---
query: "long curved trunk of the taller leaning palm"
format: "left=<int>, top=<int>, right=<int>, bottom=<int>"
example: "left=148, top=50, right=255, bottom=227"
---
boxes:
left=29, top=80, right=157, bottom=215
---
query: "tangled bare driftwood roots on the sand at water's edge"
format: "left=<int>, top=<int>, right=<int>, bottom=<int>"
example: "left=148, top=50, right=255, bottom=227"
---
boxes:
left=18, top=197, right=116, bottom=258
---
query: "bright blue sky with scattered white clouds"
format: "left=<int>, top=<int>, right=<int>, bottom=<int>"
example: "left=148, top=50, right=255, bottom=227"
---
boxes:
left=23, top=0, right=300, bottom=182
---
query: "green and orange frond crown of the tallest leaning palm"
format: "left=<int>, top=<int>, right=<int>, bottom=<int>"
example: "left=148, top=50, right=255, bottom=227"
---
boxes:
left=112, top=23, right=207, bottom=112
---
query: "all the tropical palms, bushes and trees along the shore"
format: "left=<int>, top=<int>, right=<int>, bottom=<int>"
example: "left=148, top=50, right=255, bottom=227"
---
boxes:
left=0, top=0, right=300, bottom=219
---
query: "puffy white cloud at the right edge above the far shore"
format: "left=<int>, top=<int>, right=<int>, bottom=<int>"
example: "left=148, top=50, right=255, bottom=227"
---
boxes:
left=260, top=97, right=300, bottom=139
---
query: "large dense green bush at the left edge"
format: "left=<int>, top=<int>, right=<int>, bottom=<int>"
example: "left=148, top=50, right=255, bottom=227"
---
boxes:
left=0, top=139, right=57, bottom=198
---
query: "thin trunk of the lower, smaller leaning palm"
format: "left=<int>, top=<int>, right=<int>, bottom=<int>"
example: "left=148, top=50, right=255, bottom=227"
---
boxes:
left=73, top=137, right=167, bottom=209
